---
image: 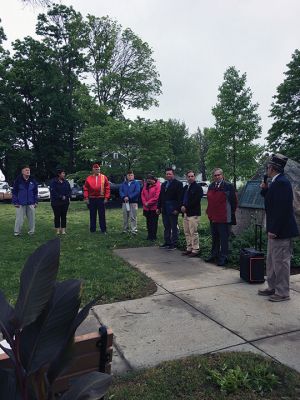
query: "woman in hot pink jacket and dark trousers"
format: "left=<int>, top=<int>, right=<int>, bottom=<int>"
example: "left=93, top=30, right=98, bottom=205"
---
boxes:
left=141, top=174, right=160, bottom=241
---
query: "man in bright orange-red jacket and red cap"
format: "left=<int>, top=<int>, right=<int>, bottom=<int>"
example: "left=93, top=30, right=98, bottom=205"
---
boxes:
left=83, top=164, right=110, bottom=234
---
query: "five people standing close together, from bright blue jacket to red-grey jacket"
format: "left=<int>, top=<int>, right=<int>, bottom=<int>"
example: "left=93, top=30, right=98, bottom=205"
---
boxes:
left=120, top=168, right=237, bottom=266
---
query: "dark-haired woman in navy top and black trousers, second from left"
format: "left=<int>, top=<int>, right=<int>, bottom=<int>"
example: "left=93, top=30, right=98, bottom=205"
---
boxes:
left=50, top=168, right=71, bottom=235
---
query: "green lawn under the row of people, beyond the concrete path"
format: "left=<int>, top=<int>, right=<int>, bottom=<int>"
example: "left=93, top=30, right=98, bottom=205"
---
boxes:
left=0, top=199, right=300, bottom=303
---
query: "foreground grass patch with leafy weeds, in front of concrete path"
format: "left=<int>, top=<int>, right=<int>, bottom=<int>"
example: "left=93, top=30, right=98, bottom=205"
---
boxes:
left=107, top=352, right=300, bottom=400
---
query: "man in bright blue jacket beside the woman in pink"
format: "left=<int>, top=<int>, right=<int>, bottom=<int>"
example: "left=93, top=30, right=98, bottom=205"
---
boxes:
left=119, top=171, right=141, bottom=235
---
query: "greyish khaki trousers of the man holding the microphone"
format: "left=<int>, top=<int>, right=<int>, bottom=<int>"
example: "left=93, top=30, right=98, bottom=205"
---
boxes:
left=267, top=239, right=292, bottom=296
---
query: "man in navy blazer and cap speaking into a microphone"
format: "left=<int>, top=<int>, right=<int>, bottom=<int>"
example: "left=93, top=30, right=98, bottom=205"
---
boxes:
left=258, top=154, right=299, bottom=302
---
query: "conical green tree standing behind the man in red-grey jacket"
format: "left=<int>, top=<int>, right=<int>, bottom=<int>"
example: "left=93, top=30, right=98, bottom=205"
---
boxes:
left=207, top=67, right=262, bottom=187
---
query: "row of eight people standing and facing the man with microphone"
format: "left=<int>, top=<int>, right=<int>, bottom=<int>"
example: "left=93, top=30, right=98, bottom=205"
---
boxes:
left=12, top=164, right=236, bottom=265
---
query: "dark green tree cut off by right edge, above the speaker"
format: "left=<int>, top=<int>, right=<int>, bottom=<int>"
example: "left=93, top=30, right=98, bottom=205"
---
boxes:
left=267, top=50, right=300, bottom=162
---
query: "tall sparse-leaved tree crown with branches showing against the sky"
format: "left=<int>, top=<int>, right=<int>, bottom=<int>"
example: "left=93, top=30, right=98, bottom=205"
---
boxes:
left=86, top=15, right=161, bottom=116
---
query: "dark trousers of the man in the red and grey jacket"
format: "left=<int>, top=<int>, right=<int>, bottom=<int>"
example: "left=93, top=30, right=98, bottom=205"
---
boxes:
left=210, top=222, right=229, bottom=261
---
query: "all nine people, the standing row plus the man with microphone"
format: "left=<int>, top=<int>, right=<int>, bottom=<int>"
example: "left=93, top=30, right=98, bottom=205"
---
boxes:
left=12, top=154, right=299, bottom=302
